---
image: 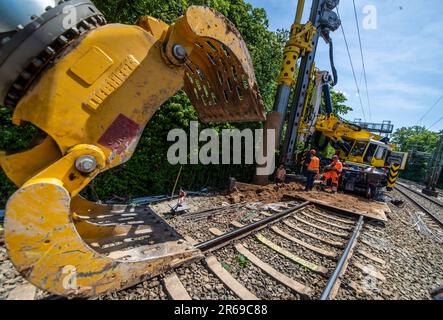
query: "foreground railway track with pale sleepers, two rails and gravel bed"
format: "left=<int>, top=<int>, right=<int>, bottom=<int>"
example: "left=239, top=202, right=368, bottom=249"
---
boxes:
left=18, top=202, right=386, bottom=300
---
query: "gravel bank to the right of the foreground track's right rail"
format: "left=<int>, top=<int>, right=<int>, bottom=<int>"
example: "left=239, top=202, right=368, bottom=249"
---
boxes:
left=338, top=193, right=443, bottom=300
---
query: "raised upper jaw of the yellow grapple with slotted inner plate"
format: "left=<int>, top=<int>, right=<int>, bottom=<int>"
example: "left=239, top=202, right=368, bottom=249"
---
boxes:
left=165, top=6, right=265, bottom=123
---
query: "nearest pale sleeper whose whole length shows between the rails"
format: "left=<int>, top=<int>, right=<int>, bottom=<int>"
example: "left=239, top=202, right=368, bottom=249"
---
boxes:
left=235, top=244, right=313, bottom=298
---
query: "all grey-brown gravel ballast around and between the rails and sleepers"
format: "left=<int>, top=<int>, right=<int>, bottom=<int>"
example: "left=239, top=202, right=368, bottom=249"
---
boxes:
left=0, top=188, right=443, bottom=300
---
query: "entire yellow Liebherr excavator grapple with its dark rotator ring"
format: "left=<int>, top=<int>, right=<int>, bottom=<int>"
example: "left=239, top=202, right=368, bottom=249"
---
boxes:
left=0, top=0, right=265, bottom=297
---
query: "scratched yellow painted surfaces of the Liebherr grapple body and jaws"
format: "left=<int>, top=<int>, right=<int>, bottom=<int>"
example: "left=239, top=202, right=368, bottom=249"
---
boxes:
left=0, top=7, right=264, bottom=297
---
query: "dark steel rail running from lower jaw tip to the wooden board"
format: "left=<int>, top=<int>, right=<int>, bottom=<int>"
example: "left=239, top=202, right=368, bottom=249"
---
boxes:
left=195, top=201, right=311, bottom=252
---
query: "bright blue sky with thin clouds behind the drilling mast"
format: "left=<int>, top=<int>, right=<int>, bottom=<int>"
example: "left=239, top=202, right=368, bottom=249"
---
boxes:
left=247, top=0, right=443, bottom=131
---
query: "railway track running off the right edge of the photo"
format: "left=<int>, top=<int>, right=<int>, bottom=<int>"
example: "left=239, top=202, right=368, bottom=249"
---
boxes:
left=396, top=183, right=443, bottom=241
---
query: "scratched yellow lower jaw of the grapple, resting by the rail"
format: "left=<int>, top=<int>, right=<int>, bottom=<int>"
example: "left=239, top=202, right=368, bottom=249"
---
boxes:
left=5, top=182, right=200, bottom=298
